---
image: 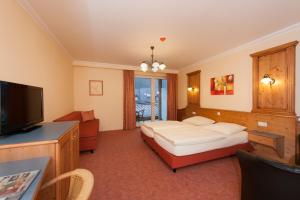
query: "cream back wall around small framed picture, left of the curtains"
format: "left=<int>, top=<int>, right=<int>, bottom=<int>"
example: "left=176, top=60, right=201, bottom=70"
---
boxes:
left=74, top=67, right=123, bottom=131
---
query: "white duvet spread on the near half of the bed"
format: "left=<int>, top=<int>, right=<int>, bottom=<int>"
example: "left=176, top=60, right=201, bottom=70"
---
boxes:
left=154, top=126, right=226, bottom=145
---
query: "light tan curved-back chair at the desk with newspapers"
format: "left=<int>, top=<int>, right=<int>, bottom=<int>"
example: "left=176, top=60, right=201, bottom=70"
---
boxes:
left=41, top=169, right=94, bottom=200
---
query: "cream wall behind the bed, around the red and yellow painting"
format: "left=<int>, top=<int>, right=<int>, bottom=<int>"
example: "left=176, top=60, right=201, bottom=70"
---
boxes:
left=178, top=24, right=300, bottom=115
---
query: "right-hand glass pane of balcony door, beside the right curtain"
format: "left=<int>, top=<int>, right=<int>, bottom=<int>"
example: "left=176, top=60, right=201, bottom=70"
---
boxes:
left=154, top=79, right=167, bottom=120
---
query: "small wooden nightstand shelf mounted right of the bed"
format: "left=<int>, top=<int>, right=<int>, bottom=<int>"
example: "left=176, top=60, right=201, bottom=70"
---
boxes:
left=248, top=131, right=284, bottom=158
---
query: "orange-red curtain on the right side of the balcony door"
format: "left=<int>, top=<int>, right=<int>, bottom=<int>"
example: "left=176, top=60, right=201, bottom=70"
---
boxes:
left=167, top=74, right=177, bottom=120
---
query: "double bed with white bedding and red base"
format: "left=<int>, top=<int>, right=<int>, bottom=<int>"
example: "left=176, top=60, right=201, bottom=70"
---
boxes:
left=141, top=117, right=253, bottom=172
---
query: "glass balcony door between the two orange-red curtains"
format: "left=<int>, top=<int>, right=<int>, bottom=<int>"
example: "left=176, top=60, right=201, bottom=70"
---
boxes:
left=135, top=76, right=167, bottom=123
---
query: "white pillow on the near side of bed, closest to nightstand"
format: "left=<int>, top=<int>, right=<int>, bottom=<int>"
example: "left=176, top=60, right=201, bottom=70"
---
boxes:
left=203, top=122, right=247, bottom=135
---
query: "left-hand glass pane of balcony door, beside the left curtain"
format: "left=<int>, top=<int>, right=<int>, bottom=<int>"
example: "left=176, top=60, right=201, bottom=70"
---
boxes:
left=135, top=77, right=152, bottom=123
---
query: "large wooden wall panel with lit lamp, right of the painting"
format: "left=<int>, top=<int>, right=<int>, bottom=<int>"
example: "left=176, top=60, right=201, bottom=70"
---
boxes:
left=251, top=41, right=298, bottom=116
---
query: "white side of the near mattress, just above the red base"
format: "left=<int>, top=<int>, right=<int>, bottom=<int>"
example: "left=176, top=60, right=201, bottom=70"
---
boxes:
left=154, top=131, right=248, bottom=156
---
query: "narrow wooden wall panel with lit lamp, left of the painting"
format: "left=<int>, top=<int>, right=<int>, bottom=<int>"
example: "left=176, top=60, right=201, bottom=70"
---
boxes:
left=187, top=71, right=201, bottom=105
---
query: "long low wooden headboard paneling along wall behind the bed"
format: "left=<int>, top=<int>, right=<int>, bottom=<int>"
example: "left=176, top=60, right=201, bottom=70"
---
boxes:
left=178, top=105, right=296, bottom=163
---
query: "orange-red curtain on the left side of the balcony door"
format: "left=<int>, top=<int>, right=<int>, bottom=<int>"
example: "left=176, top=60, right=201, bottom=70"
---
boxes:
left=123, top=70, right=136, bottom=130
